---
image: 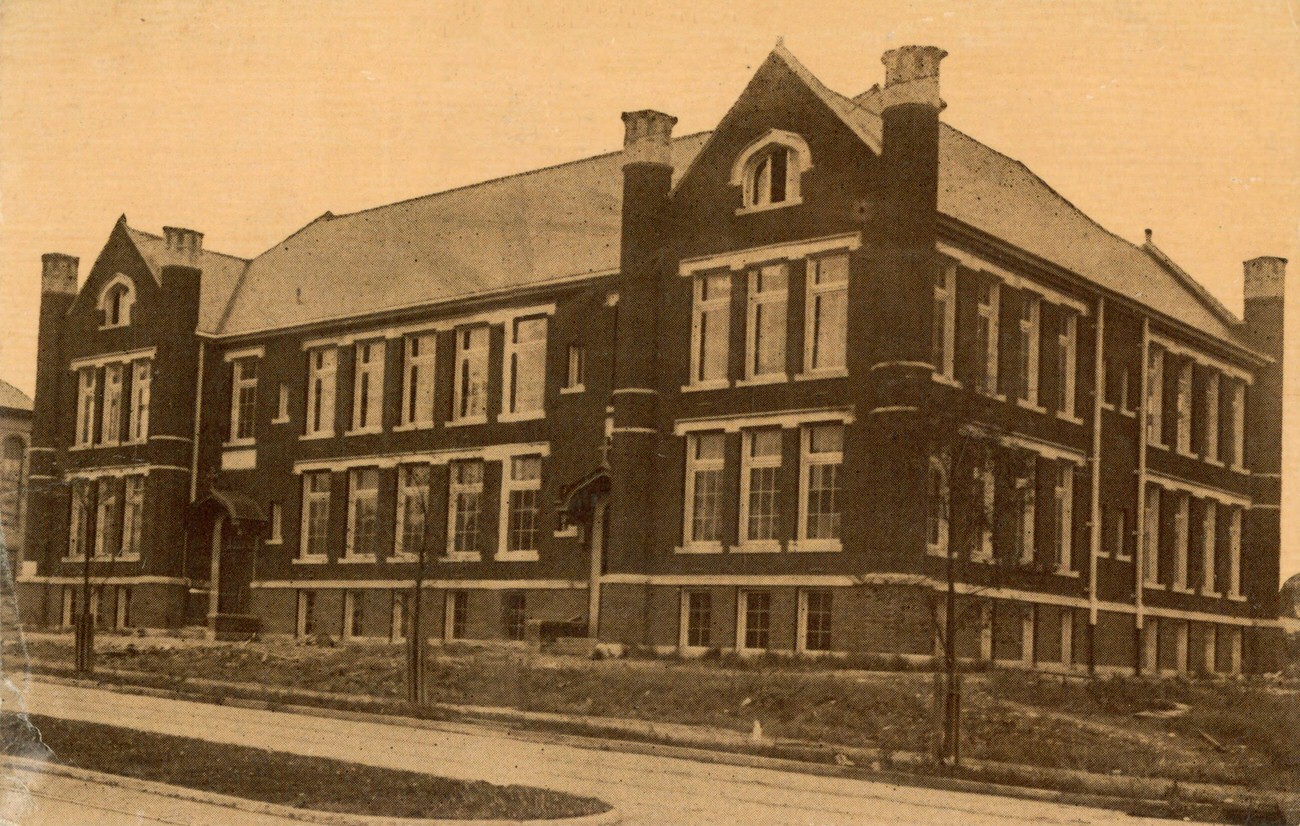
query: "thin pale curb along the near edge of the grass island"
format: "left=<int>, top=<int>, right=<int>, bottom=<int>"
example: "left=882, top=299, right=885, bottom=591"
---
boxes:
left=0, top=756, right=623, bottom=826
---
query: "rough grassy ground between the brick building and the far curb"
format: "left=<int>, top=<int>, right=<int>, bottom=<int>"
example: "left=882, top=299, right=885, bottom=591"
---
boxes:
left=7, top=639, right=1300, bottom=791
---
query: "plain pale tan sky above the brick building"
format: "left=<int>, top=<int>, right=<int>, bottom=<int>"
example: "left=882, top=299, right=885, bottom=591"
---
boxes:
left=0, top=0, right=1300, bottom=574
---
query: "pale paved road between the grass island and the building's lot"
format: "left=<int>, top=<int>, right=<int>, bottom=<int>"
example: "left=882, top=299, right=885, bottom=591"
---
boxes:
left=12, top=682, right=1206, bottom=826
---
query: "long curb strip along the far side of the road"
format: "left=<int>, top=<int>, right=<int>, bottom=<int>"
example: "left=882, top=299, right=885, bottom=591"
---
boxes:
left=20, top=671, right=1300, bottom=825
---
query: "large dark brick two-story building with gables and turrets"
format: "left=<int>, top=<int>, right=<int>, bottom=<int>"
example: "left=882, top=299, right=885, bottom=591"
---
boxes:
left=21, top=46, right=1284, bottom=673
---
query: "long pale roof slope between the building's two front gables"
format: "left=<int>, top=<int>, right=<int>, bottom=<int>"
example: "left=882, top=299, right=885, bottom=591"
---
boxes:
left=220, top=133, right=707, bottom=334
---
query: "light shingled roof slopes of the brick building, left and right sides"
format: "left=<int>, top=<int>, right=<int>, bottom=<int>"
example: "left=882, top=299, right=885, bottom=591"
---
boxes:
left=213, top=43, right=1243, bottom=343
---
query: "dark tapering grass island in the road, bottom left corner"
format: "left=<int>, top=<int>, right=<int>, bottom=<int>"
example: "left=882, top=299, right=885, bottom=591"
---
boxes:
left=0, top=713, right=608, bottom=819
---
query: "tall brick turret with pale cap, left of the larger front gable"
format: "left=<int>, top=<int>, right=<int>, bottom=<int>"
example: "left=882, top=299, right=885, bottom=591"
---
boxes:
left=603, top=109, right=677, bottom=595
